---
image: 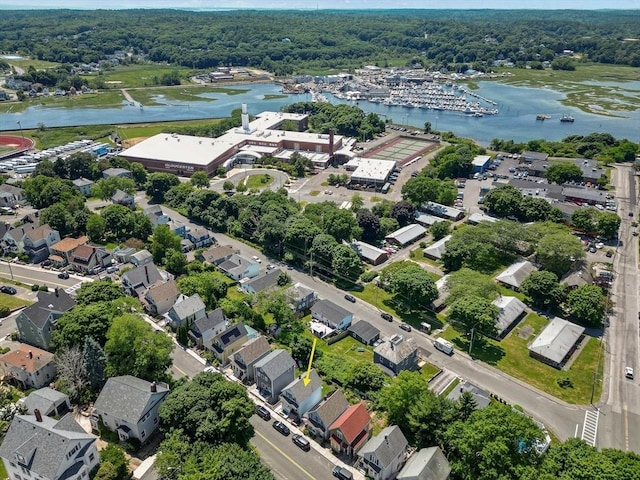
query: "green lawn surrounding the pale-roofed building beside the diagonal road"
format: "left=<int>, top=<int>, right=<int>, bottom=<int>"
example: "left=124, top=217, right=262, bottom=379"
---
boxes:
left=441, top=313, right=602, bottom=404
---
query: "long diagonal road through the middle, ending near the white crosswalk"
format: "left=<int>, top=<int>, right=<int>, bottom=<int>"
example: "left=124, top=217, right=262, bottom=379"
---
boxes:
left=136, top=194, right=585, bottom=440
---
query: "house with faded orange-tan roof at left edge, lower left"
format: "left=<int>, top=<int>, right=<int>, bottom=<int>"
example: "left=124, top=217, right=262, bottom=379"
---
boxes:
left=0, top=343, right=56, bottom=389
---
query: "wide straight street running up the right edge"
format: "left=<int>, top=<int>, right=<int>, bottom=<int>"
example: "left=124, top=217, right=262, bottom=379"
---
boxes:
left=597, top=165, right=640, bottom=452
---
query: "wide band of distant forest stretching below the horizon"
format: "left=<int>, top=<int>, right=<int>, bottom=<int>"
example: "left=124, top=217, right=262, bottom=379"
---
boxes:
left=0, top=10, right=640, bottom=75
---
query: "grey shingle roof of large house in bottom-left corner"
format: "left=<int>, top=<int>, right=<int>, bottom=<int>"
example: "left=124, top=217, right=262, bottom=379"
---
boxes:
left=0, top=414, right=96, bottom=478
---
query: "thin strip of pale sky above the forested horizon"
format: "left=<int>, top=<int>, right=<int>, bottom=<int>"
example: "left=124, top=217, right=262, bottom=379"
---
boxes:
left=0, top=0, right=640, bottom=10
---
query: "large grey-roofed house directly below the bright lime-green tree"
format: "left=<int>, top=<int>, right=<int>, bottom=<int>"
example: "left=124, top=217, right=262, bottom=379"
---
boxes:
left=91, top=375, right=169, bottom=442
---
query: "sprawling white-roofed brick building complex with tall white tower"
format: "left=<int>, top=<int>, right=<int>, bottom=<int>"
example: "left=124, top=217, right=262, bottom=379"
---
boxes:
left=120, top=105, right=344, bottom=176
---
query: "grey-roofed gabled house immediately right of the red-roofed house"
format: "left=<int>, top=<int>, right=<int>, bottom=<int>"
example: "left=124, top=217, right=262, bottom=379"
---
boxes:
left=358, top=425, right=409, bottom=480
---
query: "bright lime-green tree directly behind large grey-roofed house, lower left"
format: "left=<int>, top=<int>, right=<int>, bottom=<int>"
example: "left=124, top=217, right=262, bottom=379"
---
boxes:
left=104, top=314, right=173, bottom=381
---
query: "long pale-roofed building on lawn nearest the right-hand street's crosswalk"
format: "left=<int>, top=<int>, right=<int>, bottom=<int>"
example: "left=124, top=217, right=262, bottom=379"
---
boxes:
left=529, top=317, right=584, bottom=369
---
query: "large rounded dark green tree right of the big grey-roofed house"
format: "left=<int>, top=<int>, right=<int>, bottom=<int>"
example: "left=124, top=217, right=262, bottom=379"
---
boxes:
left=160, top=373, right=255, bottom=447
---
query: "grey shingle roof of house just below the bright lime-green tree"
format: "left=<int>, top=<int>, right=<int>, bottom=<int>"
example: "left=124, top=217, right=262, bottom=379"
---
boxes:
left=94, top=375, right=169, bottom=425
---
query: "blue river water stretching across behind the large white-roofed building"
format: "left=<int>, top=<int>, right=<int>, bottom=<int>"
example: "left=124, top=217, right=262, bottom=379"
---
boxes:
left=0, top=82, right=640, bottom=145
